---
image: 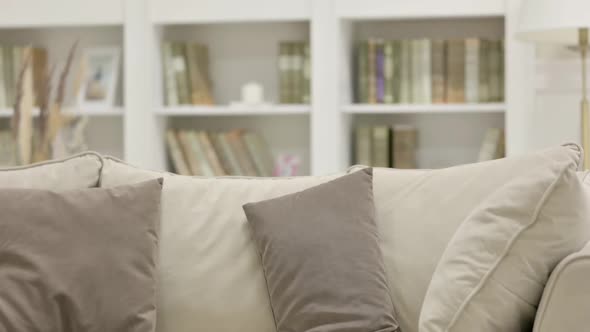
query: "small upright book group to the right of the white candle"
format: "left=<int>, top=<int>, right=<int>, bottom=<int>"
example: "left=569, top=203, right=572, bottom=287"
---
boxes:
left=279, top=41, right=311, bottom=104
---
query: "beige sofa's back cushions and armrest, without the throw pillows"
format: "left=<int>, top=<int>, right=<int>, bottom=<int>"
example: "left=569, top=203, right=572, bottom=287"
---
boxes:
left=0, top=148, right=590, bottom=332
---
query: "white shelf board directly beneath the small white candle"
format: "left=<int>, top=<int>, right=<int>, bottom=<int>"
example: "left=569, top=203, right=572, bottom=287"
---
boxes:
left=156, top=105, right=311, bottom=116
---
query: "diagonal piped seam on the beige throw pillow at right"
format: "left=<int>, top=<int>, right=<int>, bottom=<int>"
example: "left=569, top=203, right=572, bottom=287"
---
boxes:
left=445, top=165, right=577, bottom=332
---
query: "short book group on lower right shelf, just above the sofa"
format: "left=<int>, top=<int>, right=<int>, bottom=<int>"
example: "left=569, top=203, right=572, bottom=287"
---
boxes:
left=354, top=125, right=418, bottom=169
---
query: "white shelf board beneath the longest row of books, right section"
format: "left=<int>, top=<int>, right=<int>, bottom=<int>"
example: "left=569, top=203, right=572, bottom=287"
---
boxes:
left=342, top=103, right=506, bottom=114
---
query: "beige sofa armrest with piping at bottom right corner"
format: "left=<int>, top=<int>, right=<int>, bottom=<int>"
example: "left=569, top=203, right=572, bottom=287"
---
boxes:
left=533, top=243, right=590, bottom=332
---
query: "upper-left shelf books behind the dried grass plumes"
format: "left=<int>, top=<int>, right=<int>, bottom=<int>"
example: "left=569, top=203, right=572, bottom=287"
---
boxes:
left=0, top=45, right=47, bottom=108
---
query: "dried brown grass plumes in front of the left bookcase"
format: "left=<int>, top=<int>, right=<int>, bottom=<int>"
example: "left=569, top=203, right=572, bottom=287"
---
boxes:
left=11, top=42, right=79, bottom=165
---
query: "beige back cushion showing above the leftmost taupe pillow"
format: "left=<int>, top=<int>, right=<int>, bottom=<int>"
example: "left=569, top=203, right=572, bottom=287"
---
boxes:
left=0, top=152, right=102, bottom=190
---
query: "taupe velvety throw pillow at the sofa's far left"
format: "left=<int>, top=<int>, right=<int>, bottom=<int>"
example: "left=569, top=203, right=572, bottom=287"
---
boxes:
left=0, top=180, right=161, bottom=332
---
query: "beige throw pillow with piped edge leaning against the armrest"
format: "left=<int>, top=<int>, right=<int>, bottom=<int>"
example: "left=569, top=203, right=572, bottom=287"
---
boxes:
left=420, top=143, right=590, bottom=332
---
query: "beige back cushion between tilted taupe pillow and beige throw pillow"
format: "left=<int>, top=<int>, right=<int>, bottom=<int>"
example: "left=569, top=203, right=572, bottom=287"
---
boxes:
left=352, top=145, right=581, bottom=332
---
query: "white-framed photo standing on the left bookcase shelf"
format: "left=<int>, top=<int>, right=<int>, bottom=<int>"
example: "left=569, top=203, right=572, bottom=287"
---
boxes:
left=78, top=47, right=121, bottom=108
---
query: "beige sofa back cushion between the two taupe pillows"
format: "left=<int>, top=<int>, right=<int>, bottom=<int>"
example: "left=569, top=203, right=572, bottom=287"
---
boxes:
left=101, top=158, right=340, bottom=332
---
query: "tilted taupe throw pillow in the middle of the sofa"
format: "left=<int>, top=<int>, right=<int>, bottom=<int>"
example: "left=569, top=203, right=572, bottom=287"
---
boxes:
left=244, top=168, right=398, bottom=332
